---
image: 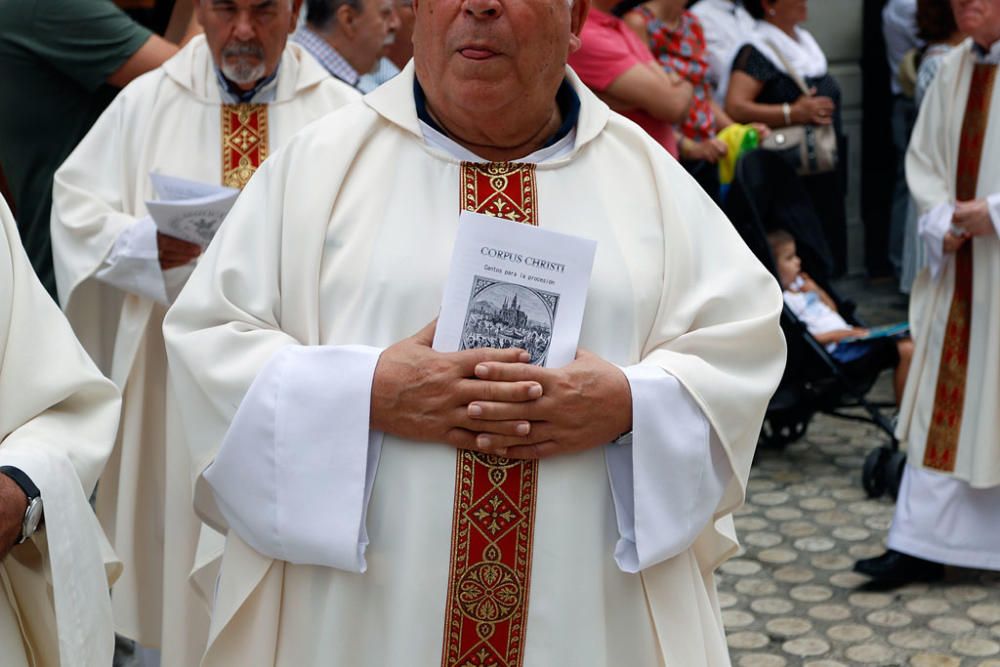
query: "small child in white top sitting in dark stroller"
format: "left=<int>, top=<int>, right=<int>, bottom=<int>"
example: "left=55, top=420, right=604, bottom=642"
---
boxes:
left=767, top=229, right=913, bottom=405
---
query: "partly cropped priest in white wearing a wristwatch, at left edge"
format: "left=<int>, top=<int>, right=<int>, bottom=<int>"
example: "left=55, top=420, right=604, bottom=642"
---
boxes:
left=0, top=200, right=121, bottom=667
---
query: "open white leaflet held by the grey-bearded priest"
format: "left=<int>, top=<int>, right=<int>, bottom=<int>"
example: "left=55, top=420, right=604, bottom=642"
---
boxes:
left=146, top=174, right=240, bottom=246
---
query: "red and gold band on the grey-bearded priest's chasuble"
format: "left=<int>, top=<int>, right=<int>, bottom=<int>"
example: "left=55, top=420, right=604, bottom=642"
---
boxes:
left=222, top=104, right=268, bottom=190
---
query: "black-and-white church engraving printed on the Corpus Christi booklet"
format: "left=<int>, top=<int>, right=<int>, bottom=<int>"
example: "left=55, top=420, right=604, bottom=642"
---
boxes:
left=461, top=276, right=559, bottom=366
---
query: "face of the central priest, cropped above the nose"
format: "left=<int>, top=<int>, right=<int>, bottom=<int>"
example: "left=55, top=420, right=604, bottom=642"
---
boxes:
left=413, top=0, right=589, bottom=113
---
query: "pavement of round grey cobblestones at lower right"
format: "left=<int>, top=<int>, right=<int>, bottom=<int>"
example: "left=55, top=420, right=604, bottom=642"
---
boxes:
left=719, top=285, right=1000, bottom=667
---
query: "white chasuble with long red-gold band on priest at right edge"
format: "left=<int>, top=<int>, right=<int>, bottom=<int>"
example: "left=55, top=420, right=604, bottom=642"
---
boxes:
left=897, top=40, right=1000, bottom=488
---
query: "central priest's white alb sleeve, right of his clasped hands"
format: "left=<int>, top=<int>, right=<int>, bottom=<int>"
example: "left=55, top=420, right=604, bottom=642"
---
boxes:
left=605, top=365, right=733, bottom=573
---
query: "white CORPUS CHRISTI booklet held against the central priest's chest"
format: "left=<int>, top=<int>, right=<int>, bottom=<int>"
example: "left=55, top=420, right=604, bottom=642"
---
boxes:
left=434, top=213, right=597, bottom=368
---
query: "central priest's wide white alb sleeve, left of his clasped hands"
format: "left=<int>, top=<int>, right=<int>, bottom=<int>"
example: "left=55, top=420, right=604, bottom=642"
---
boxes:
left=204, top=345, right=382, bottom=572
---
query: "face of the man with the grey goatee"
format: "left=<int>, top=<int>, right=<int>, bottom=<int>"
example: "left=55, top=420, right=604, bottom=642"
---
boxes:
left=197, top=0, right=302, bottom=90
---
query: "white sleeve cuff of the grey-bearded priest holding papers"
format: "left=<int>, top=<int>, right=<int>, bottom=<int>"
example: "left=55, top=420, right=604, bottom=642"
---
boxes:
left=95, top=216, right=169, bottom=304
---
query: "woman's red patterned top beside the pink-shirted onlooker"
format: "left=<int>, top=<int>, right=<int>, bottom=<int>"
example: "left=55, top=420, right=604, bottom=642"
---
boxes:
left=632, top=5, right=715, bottom=141
